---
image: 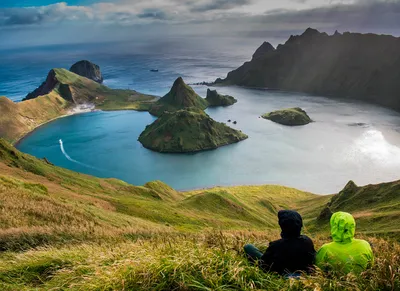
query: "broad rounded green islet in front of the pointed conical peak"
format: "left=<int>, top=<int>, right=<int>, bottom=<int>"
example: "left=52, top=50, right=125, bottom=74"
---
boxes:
left=139, top=108, right=247, bottom=153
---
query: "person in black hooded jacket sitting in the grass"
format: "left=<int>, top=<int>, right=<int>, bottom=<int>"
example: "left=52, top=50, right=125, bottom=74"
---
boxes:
left=244, top=210, right=315, bottom=276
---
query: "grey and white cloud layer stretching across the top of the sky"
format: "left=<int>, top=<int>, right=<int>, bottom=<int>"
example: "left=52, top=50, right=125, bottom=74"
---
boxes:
left=0, top=0, right=400, bottom=37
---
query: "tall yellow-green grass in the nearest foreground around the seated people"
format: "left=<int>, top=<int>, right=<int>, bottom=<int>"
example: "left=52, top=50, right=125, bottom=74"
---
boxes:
left=0, top=232, right=400, bottom=291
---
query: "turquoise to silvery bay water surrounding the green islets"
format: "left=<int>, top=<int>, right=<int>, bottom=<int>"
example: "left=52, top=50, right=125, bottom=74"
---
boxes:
left=19, top=86, right=400, bottom=194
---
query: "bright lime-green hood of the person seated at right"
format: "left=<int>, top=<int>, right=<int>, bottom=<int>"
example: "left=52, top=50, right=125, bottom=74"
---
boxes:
left=331, top=212, right=356, bottom=243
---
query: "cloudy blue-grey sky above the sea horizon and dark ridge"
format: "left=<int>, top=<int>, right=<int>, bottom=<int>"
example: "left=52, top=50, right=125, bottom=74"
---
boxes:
left=0, top=0, right=400, bottom=47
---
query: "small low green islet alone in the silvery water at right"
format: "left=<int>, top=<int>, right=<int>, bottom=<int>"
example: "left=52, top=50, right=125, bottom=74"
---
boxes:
left=262, top=107, right=312, bottom=126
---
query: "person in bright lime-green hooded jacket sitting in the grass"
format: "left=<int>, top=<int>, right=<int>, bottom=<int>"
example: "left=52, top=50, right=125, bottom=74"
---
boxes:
left=316, top=212, right=374, bottom=274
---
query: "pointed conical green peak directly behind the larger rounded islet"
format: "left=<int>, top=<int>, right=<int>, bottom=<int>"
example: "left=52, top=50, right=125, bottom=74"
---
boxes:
left=149, top=77, right=208, bottom=116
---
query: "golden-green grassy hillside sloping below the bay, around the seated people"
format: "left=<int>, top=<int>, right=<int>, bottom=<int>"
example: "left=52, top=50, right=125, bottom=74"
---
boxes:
left=0, top=140, right=400, bottom=290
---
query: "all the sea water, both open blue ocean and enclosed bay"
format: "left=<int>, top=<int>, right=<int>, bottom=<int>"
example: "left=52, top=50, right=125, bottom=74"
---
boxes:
left=0, top=37, right=400, bottom=194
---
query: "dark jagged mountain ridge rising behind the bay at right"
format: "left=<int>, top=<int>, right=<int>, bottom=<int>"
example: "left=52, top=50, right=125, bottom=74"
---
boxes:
left=215, top=28, right=400, bottom=110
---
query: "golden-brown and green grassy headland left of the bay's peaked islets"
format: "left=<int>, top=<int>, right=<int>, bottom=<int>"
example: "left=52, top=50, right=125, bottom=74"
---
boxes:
left=0, top=69, right=156, bottom=143
